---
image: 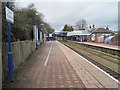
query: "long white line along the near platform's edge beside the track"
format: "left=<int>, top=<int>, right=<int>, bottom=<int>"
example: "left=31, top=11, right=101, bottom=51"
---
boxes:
left=61, top=43, right=120, bottom=83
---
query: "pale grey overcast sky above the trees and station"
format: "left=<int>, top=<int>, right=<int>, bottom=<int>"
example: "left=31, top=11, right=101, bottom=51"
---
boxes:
left=16, top=0, right=118, bottom=31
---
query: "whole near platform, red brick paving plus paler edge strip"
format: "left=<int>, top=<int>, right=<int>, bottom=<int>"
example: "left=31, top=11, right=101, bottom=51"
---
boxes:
left=3, top=41, right=119, bottom=88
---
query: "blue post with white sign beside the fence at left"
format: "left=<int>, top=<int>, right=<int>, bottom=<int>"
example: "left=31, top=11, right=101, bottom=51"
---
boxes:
left=6, top=0, right=14, bottom=82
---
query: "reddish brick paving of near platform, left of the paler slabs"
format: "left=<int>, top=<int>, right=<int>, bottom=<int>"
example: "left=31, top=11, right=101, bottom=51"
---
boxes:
left=3, top=41, right=85, bottom=88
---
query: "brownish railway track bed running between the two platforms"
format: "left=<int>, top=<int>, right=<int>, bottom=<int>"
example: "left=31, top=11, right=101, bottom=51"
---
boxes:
left=61, top=41, right=120, bottom=80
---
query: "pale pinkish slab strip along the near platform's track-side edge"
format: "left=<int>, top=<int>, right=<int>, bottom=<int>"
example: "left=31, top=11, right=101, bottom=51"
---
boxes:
left=57, top=42, right=119, bottom=88
